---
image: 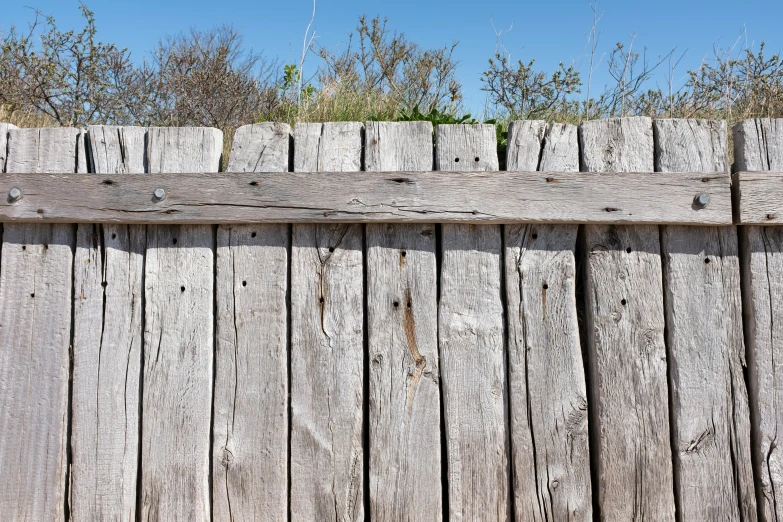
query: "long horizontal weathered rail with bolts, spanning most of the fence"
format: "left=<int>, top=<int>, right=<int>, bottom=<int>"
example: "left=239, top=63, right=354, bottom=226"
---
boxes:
left=0, top=172, right=732, bottom=221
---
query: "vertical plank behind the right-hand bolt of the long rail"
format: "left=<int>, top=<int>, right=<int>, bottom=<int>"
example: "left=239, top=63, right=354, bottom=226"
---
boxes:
left=653, top=120, right=757, bottom=521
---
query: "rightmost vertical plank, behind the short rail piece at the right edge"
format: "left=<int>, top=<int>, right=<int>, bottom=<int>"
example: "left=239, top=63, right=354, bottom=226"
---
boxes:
left=733, top=119, right=783, bottom=522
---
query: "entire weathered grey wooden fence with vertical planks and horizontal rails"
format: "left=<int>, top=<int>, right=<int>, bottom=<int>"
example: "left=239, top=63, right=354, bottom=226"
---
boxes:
left=0, top=118, right=783, bottom=522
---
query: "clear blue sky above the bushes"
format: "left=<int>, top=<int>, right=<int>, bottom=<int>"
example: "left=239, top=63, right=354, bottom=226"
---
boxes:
left=0, top=0, right=783, bottom=115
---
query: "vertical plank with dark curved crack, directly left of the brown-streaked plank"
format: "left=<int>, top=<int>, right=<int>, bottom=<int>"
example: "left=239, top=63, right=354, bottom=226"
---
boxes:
left=291, top=122, right=364, bottom=522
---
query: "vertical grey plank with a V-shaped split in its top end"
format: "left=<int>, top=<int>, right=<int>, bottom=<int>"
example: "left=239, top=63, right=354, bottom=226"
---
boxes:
left=505, top=122, right=593, bottom=522
